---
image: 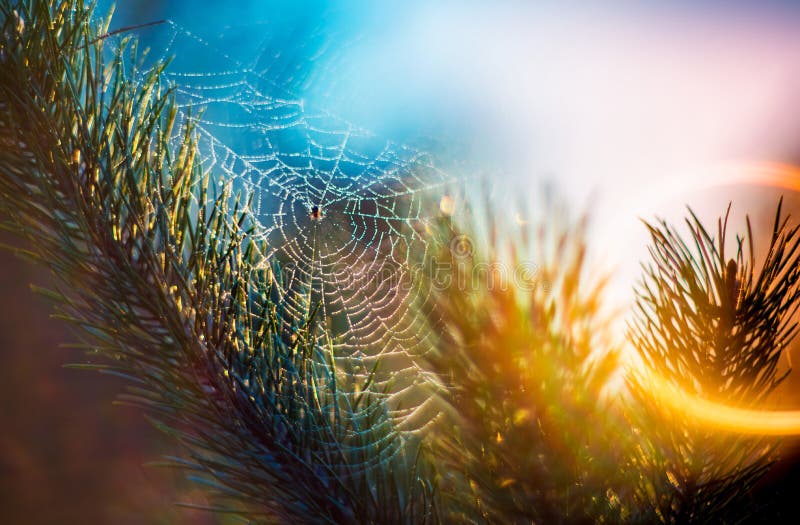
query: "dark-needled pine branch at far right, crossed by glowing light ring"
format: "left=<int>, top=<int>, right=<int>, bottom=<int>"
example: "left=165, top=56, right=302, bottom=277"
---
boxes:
left=630, top=200, right=800, bottom=523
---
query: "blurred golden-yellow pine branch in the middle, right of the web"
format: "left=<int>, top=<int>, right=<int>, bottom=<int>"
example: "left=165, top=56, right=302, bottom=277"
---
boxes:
left=422, top=200, right=624, bottom=523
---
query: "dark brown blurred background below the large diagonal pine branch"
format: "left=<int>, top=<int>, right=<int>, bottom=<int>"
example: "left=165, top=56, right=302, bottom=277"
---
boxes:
left=0, top=214, right=221, bottom=525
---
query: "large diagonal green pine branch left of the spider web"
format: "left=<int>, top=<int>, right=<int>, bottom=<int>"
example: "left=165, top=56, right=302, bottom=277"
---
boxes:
left=0, top=0, right=436, bottom=523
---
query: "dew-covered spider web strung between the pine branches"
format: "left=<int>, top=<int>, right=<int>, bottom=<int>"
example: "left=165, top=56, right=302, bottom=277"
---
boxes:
left=137, top=22, right=455, bottom=431
